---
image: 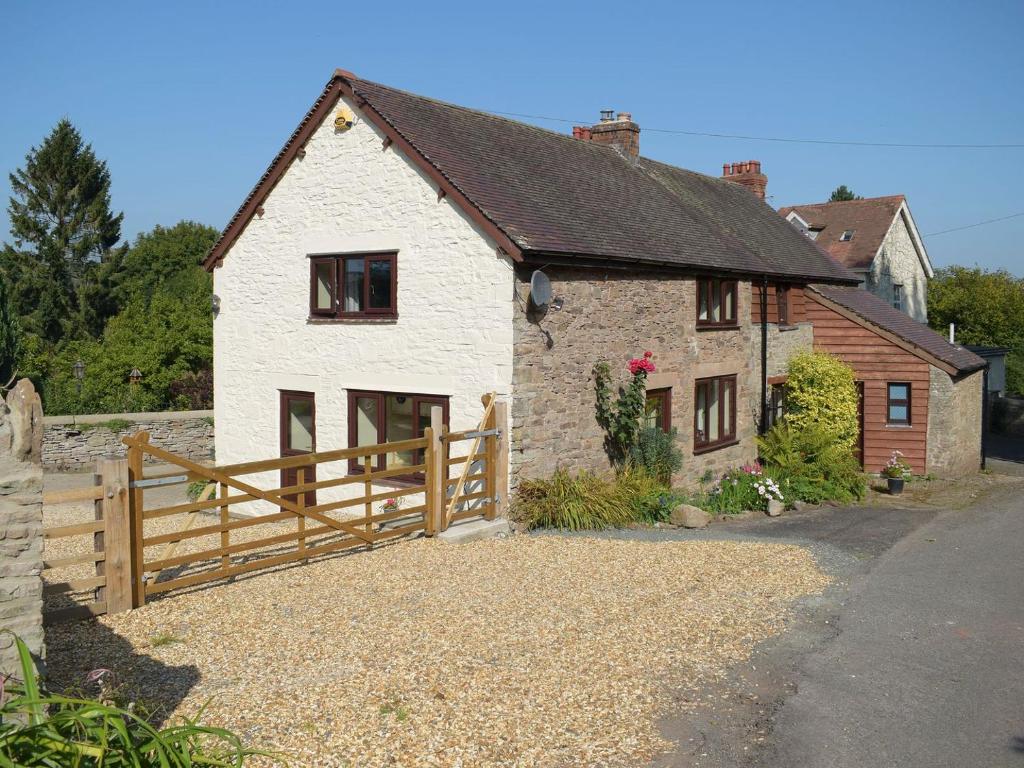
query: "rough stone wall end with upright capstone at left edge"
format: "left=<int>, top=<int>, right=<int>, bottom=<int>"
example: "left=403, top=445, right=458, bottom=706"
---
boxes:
left=0, top=379, right=44, bottom=677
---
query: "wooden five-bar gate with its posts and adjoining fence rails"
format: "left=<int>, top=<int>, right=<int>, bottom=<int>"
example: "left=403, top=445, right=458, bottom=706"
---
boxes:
left=43, top=393, right=509, bottom=622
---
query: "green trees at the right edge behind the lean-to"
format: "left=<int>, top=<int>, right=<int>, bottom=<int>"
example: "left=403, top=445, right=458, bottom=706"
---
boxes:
left=928, top=266, right=1024, bottom=392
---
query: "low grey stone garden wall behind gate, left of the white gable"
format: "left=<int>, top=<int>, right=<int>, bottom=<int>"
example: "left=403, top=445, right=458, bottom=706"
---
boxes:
left=42, top=411, right=215, bottom=470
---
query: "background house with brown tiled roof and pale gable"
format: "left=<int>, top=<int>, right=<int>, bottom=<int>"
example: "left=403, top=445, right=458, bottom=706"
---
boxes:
left=779, top=195, right=935, bottom=323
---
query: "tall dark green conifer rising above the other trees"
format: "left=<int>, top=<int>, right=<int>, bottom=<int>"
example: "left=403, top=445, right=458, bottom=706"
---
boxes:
left=0, top=118, right=123, bottom=341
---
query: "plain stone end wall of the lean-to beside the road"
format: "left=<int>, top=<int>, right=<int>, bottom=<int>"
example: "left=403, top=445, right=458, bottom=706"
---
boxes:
left=928, top=366, right=984, bottom=477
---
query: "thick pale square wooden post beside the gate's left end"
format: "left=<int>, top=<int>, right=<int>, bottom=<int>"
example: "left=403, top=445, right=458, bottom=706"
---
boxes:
left=96, top=458, right=133, bottom=613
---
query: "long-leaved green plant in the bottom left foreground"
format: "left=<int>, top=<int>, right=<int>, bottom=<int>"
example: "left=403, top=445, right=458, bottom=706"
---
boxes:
left=0, top=636, right=284, bottom=768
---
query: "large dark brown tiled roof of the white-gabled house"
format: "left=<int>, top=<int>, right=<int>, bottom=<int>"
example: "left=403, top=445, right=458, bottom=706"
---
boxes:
left=207, top=73, right=857, bottom=283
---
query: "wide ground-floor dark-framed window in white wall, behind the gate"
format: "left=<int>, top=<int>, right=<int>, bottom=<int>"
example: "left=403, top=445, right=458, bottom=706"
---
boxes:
left=348, top=390, right=449, bottom=481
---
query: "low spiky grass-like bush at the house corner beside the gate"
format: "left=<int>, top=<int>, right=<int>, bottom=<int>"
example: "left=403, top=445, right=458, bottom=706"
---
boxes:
left=510, top=467, right=679, bottom=530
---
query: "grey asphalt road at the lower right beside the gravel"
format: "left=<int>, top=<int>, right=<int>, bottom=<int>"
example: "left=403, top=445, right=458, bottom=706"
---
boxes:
left=748, top=486, right=1024, bottom=768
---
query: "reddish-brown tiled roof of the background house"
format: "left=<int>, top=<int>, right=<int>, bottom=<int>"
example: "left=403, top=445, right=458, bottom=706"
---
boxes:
left=778, top=195, right=905, bottom=269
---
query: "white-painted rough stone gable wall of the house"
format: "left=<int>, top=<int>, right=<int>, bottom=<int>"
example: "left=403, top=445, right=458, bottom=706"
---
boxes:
left=214, top=97, right=514, bottom=514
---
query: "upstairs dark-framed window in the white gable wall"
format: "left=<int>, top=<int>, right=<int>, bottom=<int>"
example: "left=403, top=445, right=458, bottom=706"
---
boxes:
left=309, top=251, right=398, bottom=319
